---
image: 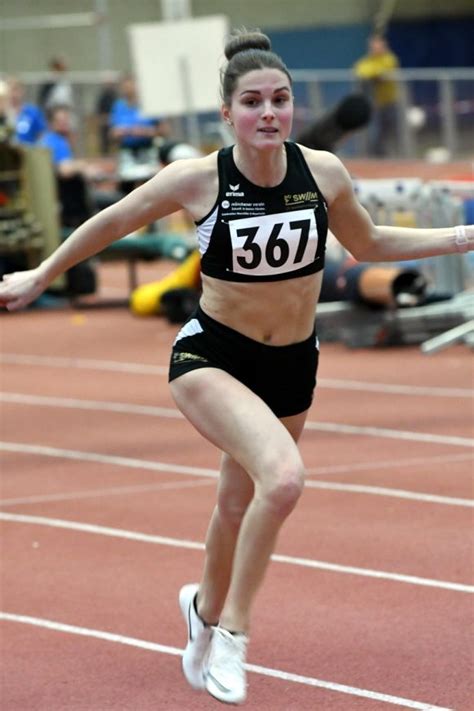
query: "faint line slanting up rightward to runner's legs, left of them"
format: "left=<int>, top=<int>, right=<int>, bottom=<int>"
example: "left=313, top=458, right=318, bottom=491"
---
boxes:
left=0, top=479, right=215, bottom=506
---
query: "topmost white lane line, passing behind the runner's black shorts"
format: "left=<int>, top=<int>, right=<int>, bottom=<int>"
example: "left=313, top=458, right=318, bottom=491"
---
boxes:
left=0, top=353, right=474, bottom=398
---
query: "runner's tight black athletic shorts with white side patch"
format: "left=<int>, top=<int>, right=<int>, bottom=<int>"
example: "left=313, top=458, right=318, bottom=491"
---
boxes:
left=169, top=306, right=319, bottom=417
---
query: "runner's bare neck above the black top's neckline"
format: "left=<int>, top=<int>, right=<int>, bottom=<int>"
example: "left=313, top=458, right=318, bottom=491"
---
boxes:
left=232, top=144, right=287, bottom=188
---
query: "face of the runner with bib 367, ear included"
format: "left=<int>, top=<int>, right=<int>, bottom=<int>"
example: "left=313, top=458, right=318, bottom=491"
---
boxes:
left=222, top=69, right=293, bottom=149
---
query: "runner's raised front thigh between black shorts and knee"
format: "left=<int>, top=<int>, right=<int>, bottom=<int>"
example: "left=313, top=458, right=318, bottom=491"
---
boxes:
left=170, top=368, right=301, bottom=481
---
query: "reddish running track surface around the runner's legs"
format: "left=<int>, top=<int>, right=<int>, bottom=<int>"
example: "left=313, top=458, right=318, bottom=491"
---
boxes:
left=0, top=265, right=474, bottom=711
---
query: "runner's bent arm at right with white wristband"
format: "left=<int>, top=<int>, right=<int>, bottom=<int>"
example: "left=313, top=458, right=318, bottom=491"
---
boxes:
left=316, top=154, right=474, bottom=262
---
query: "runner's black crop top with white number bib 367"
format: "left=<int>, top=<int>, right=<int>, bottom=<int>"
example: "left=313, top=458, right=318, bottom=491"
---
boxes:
left=196, top=142, right=328, bottom=281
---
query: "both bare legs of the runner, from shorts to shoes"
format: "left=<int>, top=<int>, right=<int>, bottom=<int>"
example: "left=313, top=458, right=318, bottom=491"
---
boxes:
left=172, top=369, right=306, bottom=631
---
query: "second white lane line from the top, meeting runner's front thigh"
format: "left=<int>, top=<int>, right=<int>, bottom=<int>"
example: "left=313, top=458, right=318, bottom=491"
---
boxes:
left=0, top=392, right=474, bottom=447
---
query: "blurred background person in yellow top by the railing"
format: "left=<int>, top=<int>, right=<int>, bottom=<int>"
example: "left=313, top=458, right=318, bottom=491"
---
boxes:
left=353, top=34, right=399, bottom=156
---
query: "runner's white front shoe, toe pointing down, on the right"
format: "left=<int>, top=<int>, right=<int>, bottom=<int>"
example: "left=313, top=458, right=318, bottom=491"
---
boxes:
left=206, top=627, right=248, bottom=704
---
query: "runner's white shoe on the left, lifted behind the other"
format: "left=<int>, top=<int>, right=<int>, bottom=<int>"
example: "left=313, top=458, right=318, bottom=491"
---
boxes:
left=179, top=583, right=212, bottom=689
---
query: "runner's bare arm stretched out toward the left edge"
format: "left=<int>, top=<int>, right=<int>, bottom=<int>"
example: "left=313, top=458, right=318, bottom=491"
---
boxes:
left=0, top=159, right=199, bottom=311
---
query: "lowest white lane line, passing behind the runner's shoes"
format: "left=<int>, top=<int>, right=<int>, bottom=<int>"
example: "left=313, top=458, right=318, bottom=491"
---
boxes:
left=0, top=612, right=453, bottom=711
